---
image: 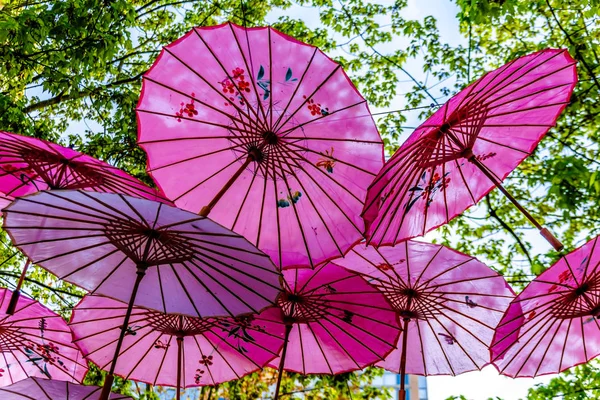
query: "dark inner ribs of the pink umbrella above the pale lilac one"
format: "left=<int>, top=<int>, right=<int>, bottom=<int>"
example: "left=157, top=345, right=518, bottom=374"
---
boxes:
left=19, top=149, right=104, bottom=189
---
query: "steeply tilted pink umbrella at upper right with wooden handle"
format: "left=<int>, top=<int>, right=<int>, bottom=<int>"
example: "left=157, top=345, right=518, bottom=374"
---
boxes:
left=363, top=50, right=577, bottom=249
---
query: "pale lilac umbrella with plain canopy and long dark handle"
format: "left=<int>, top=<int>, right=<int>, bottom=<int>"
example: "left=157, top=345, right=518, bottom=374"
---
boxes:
left=4, top=190, right=281, bottom=400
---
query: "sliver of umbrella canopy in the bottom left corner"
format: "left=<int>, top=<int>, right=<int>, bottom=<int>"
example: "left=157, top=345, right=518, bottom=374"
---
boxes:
left=0, top=378, right=132, bottom=400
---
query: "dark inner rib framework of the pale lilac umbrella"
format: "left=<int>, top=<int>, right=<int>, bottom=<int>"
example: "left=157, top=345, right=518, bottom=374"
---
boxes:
left=104, top=219, right=194, bottom=266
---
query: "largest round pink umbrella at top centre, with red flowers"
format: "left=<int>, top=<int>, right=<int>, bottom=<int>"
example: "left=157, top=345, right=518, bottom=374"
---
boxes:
left=137, top=23, right=383, bottom=268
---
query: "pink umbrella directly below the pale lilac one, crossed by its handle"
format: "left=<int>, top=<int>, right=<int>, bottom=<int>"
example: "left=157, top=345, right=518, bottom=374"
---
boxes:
left=70, top=296, right=285, bottom=399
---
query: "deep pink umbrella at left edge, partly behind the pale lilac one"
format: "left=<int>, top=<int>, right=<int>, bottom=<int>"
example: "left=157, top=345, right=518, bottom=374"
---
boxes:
left=0, top=131, right=170, bottom=314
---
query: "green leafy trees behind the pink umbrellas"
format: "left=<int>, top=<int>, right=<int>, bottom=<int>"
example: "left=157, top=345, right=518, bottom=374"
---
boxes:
left=0, top=0, right=600, bottom=399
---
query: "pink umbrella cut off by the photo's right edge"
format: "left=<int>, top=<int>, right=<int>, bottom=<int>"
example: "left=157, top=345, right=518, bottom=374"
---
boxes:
left=491, top=237, right=600, bottom=378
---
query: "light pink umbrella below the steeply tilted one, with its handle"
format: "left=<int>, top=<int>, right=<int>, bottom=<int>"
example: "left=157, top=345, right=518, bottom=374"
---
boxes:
left=333, top=241, right=514, bottom=400
